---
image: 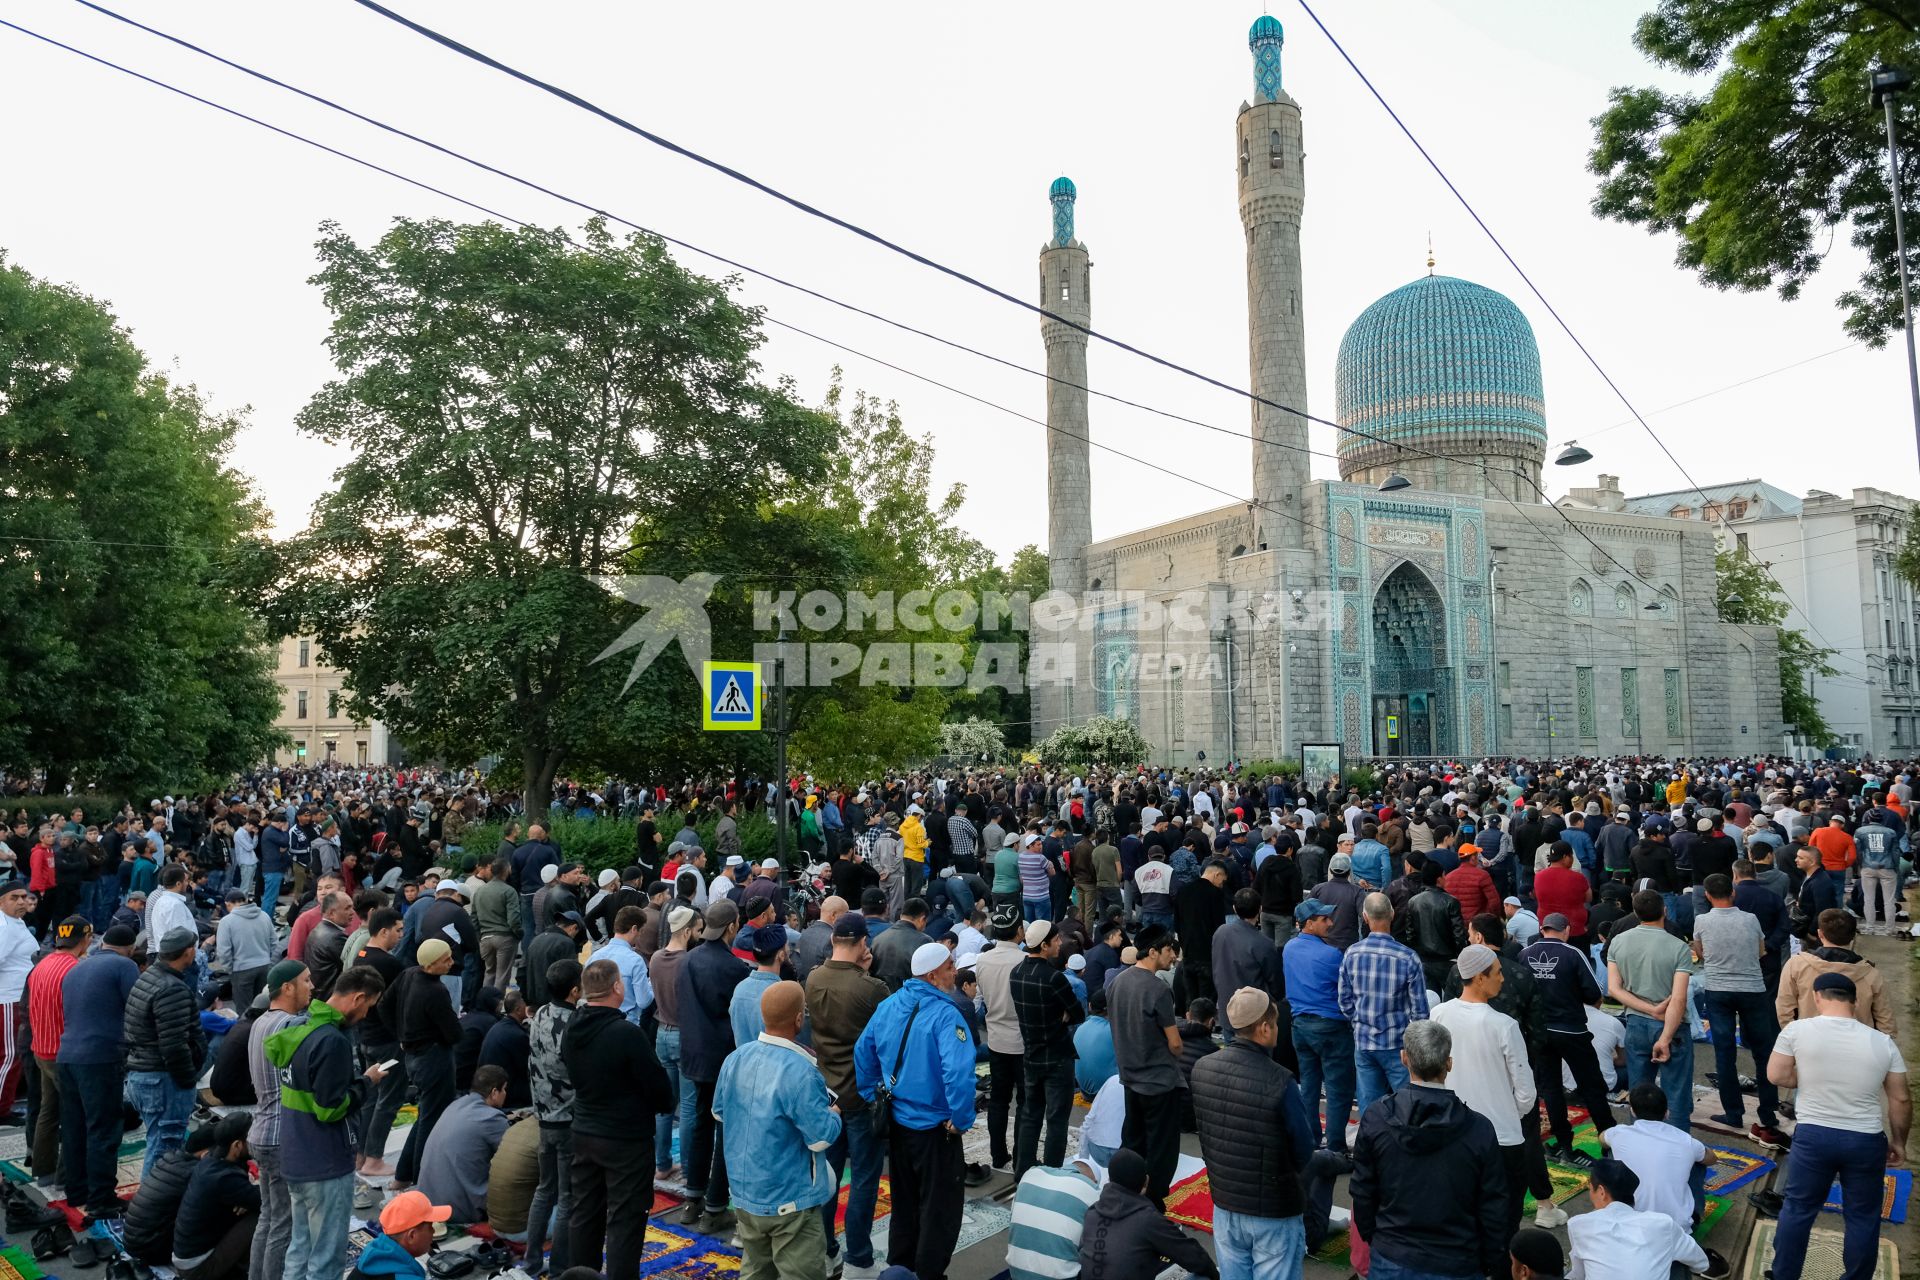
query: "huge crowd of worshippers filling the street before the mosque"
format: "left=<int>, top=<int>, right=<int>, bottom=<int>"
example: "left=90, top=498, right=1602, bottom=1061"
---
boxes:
left=0, top=760, right=1912, bottom=1280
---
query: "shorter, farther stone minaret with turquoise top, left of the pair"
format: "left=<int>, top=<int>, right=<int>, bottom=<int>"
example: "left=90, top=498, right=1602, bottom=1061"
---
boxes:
left=1041, top=178, right=1092, bottom=597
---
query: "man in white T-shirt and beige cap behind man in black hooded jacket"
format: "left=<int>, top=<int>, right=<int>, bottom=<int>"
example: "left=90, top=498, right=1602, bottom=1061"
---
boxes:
left=1432, top=942, right=1538, bottom=1238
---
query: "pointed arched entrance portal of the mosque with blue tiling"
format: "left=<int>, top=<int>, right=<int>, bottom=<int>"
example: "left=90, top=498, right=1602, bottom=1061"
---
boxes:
left=1373, top=562, right=1453, bottom=756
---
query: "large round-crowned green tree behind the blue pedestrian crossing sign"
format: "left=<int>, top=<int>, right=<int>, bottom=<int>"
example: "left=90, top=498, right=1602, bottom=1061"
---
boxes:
left=275, top=219, right=835, bottom=810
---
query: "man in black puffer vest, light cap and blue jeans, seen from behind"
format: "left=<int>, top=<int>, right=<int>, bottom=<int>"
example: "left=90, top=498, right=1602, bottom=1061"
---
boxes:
left=1192, top=986, right=1325, bottom=1276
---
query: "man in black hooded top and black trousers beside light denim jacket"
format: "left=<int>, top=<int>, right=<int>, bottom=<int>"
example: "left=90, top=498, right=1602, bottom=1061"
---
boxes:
left=561, top=955, right=675, bottom=1280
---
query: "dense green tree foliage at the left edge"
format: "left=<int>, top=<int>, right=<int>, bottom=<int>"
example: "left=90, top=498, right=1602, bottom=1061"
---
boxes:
left=0, top=257, right=282, bottom=793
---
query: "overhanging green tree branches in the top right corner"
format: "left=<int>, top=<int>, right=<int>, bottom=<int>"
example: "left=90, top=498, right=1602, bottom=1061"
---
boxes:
left=1588, top=0, right=1920, bottom=345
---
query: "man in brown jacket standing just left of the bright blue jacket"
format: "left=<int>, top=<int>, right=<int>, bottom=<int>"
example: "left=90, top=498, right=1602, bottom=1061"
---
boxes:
left=806, top=912, right=894, bottom=1276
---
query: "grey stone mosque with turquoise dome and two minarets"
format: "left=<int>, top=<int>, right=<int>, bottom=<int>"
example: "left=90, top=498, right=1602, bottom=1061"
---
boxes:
left=1033, top=17, right=1786, bottom=764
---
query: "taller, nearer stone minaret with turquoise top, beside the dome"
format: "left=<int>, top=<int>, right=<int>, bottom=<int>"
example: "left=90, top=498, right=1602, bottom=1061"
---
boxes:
left=1235, top=15, right=1308, bottom=549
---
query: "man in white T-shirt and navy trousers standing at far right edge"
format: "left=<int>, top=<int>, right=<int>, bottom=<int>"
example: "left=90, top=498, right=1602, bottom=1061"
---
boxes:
left=1766, top=973, right=1912, bottom=1280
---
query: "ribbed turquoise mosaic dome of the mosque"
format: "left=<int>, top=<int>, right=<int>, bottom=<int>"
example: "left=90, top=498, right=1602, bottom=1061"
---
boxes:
left=1334, top=276, right=1548, bottom=461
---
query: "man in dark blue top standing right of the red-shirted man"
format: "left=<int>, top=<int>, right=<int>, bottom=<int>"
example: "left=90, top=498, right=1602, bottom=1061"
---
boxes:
left=54, top=925, right=141, bottom=1228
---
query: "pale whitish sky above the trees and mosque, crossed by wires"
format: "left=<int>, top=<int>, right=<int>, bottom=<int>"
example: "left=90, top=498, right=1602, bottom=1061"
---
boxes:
left=0, top=0, right=1920, bottom=558
